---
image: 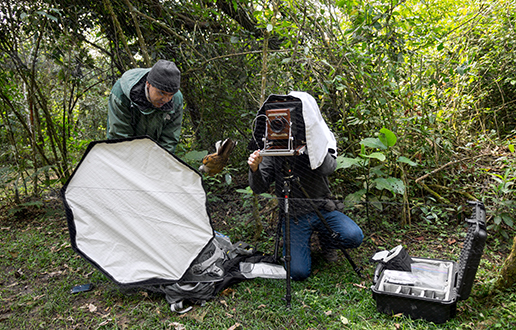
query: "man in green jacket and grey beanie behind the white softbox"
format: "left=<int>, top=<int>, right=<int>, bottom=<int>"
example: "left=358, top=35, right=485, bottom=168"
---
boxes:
left=107, top=60, right=183, bottom=153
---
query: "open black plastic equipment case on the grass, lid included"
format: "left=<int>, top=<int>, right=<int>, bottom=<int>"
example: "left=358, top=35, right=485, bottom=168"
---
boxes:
left=371, top=202, right=487, bottom=323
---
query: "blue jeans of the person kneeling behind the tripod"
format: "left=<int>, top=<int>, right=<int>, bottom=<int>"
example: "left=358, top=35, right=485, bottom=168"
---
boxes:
left=283, top=210, right=364, bottom=281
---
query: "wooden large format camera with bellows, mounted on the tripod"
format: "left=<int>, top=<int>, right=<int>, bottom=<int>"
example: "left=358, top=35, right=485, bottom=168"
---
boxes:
left=249, top=94, right=306, bottom=156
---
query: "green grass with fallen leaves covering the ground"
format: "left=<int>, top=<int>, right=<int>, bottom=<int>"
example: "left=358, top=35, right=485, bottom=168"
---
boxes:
left=0, top=197, right=516, bottom=329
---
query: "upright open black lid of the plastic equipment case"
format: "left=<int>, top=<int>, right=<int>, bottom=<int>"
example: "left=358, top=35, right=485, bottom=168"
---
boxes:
left=457, top=201, right=487, bottom=300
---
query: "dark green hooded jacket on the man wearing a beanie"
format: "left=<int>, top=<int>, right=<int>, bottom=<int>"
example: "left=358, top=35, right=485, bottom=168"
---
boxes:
left=107, top=68, right=183, bottom=153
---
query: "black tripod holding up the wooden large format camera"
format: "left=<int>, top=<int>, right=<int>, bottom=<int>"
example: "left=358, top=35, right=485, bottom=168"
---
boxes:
left=274, top=158, right=362, bottom=308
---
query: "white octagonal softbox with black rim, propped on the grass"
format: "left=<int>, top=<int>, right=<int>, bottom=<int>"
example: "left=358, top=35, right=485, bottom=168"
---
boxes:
left=61, top=138, right=214, bottom=286
